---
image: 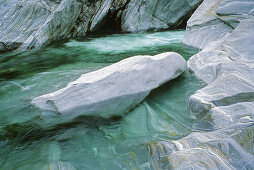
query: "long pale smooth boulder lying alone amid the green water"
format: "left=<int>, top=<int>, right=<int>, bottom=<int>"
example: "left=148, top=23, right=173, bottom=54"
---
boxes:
left=32, top=53, right=186, bottom=117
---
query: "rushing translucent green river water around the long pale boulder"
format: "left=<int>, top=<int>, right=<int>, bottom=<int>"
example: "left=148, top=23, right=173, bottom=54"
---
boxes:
left=0, top=31, right=202, bottom=169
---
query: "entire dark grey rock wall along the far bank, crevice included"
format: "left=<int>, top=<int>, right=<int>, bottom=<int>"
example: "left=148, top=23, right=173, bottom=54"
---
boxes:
left=0, top=0, right=202, bottom=51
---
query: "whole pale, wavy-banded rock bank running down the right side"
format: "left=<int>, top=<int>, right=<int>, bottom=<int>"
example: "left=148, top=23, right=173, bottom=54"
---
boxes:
left=149, top=1, right=254, bottom=169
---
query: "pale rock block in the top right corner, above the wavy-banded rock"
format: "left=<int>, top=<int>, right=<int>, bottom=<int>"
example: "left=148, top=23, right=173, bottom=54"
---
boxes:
left=183, top=0, right=254, bottom=49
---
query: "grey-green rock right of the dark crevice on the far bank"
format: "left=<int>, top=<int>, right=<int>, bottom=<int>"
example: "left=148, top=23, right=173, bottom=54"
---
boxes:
left=121, top=0, right=202, bottom=32
